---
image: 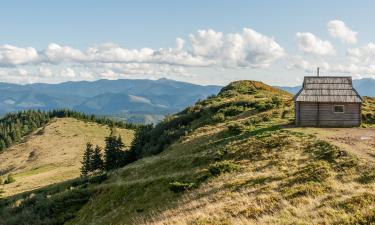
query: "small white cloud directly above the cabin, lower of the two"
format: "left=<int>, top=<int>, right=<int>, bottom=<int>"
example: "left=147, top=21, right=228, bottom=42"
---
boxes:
left=296, top=32, right=335, bottom=56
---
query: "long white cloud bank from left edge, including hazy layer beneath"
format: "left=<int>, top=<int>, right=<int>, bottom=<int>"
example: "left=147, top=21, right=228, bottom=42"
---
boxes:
left=0, top=28, right=285, bottom=82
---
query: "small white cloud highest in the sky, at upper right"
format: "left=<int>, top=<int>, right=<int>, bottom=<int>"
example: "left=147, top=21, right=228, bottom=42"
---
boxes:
left=327, top=20, right=358, bottom=44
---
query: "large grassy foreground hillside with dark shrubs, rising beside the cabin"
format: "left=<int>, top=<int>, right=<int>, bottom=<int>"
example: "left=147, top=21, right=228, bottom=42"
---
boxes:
left=0, top=81, right=375, bottom=225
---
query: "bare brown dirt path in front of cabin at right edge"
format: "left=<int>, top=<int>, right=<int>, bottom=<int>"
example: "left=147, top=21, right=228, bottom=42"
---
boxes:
left=289, top=128, right=375, bottom=162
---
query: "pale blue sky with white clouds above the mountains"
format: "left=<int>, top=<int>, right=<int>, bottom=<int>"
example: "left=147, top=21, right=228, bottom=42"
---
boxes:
left=0, top=0, right=375, bottom=85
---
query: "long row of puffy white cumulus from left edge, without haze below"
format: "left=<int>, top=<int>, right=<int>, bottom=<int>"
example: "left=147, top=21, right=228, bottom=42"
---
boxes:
left=0, top=28, right=284, bottom=69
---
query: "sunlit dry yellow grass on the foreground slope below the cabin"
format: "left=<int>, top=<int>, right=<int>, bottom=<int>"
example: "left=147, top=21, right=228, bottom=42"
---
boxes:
left=133, top=128, right=375, bottom=225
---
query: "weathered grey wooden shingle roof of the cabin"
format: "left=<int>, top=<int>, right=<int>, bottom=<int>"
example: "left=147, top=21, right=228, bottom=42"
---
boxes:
left=294, top=76, right=362, bottom=103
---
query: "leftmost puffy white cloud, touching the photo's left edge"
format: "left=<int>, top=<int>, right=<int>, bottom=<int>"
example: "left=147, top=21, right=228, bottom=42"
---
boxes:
left=0, top=45, right=38, bottom=66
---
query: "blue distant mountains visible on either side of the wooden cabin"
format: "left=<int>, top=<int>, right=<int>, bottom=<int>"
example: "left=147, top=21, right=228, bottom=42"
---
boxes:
left=278, top=78, right=375, bottom=97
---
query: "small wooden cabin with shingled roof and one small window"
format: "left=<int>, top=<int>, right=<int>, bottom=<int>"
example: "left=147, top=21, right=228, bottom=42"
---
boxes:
left=294, top=76, right=363, bottom=127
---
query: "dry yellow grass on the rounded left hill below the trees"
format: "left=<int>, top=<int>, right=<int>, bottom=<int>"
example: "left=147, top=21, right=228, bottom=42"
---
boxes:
left=0, top=118, right=134, bottom=196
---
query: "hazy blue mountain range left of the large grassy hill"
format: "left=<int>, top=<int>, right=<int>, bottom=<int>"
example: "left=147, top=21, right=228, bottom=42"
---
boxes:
left=0, top=79, right=221, bottom=122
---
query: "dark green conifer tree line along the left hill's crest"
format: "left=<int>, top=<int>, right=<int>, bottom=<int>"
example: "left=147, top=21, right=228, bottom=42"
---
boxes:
left=0, top=109, right=138, bottom=152
